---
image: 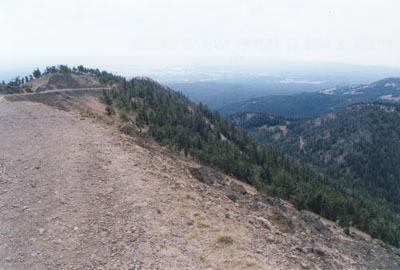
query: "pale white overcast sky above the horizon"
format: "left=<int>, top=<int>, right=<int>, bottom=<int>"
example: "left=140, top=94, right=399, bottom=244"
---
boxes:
left=0, top=0, right=400, bottom=70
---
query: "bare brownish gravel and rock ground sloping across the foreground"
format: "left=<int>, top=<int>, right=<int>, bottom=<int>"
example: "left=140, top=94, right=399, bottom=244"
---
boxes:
left=0, top=100, right=400, bottom=270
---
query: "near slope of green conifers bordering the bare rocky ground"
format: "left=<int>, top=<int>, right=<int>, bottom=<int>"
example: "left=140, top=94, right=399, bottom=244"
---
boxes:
left=97, top=71, right=400, bottom=245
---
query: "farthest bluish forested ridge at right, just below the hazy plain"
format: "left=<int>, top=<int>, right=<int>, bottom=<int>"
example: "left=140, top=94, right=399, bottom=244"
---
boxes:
left=219, top=78, right=400, bottom=117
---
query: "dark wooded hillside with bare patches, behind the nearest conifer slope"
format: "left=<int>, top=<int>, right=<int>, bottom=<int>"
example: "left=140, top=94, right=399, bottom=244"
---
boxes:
left=230, top=104, right=400, bottom=243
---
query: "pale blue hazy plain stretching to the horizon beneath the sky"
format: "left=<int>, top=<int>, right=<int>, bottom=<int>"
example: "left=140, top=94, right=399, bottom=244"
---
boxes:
left=125, top=61, right=400, bottom=109
